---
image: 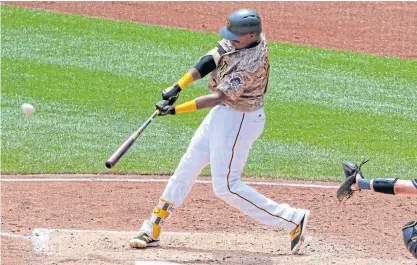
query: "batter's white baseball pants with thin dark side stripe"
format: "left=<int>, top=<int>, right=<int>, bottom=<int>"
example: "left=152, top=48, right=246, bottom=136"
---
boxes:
left=140, top=105, right=305, bottom=236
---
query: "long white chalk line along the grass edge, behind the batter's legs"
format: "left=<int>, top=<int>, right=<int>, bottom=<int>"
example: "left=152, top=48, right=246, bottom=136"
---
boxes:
left=0, top=178, right=338, bottom=189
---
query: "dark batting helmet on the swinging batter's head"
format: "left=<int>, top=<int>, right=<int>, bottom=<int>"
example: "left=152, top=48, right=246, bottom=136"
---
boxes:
left=220, top=8, right=262, bottom=40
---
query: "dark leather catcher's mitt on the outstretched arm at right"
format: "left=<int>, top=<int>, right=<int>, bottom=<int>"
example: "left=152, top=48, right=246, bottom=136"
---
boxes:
left=336, top=159, right=369, bottom=201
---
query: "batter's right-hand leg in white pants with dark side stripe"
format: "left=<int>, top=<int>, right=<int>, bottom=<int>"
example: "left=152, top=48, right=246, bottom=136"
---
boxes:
left=210, top=105, right=309, bottom=252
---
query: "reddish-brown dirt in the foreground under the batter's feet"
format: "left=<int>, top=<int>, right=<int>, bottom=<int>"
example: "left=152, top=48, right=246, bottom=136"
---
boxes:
left=1, top=175, right=417, bottom=265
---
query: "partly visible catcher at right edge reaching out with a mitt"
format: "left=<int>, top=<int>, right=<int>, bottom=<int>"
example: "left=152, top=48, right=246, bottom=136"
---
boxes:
left=336, top=160, right=417, bottom=259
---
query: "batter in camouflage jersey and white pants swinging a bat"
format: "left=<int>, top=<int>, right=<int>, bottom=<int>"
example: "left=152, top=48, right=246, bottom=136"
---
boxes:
left=130, top=9, right=310, bottom=253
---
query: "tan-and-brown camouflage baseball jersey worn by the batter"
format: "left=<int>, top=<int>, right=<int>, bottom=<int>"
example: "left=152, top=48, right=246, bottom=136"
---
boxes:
left=209, top=33, right=269, bottom=112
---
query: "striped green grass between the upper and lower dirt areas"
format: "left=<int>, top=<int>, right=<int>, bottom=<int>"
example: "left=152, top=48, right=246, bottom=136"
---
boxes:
left=1, top=5, right=417, bottom=180
